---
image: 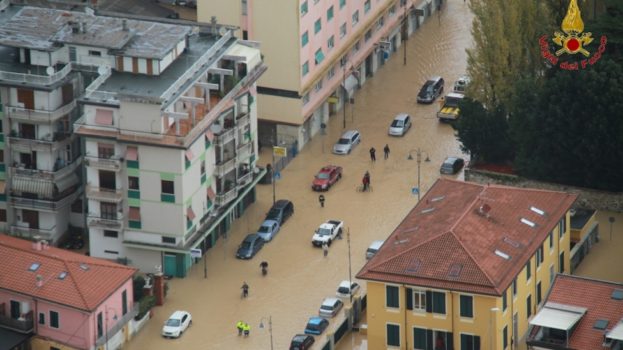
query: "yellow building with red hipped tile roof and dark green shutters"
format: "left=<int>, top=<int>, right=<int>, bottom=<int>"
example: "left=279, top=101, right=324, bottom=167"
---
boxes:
left=357, top=179, right=576, bottom=350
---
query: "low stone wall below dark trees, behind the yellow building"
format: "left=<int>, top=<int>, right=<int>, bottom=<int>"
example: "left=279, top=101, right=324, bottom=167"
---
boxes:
left=465, top=168, right=623, bottom=213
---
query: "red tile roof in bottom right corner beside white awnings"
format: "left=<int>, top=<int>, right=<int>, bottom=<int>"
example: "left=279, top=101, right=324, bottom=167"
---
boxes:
left=547, top=275, right=623, bottom=349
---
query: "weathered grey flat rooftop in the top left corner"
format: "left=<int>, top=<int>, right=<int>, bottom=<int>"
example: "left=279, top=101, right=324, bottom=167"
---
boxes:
left=0, top=6, right=192, bottom=59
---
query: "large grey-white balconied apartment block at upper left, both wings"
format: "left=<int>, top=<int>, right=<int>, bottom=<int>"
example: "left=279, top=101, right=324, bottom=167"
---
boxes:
left=0, top=6, right=266, bottom=277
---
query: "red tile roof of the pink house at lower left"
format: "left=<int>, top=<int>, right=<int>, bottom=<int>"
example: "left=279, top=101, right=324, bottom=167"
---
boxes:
left=0, top=234, right=137, bottom=311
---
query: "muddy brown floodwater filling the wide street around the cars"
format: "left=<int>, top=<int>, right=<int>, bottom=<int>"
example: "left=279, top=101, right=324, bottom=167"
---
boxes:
left=125, top=0, right=472, bottom=350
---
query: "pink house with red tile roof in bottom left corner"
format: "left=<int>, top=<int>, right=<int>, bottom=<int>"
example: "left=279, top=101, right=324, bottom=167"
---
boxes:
left=0, top=234, right=137, bottom=350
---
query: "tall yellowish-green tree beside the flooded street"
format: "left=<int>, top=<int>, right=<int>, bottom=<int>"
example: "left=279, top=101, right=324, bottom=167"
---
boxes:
left=467, top=0, right=551, bottom=109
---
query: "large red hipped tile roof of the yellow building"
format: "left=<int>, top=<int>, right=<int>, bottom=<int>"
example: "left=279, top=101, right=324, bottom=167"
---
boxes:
left=357, top=179, right=577, bottom=296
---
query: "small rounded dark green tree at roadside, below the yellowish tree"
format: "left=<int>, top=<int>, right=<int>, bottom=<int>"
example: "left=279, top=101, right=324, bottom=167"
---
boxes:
left=453, top=97, right=512, bottom=163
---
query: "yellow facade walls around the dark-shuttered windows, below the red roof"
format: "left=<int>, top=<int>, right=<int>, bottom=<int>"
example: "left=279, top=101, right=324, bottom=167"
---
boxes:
left=366, top=215, right=571, bottom=350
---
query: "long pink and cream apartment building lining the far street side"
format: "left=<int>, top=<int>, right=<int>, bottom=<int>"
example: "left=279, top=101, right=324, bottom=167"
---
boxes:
left=197, top=0, right=442, bottom=148
